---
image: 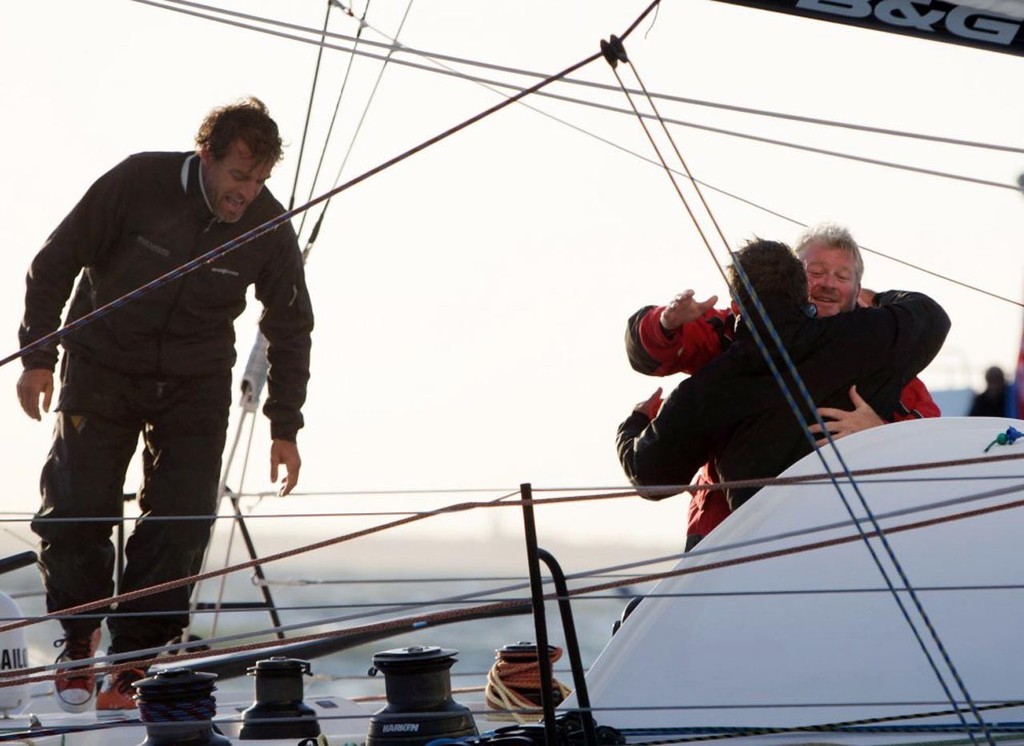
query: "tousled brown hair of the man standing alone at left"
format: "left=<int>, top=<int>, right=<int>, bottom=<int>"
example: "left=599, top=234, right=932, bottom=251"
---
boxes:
left=196, top=96, right=284, bottom=166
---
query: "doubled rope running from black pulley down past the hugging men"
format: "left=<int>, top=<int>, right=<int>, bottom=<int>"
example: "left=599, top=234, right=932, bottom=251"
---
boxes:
left=605, top=38, right=993, bottom=744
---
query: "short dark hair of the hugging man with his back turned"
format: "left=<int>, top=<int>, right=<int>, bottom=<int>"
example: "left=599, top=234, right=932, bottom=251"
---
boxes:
left=726, top=237, right=807, bottom=313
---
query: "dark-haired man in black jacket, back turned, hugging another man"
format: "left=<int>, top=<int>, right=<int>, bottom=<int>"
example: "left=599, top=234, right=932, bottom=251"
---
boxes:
left=617, top=239, right=949, bottom=510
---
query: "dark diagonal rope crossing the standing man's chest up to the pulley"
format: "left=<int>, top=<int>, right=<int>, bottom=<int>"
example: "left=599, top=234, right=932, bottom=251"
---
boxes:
left=0, top=0, right=626, bottom=367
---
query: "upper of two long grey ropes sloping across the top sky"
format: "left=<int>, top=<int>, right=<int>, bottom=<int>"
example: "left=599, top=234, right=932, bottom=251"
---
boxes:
left=135, top=0, right=1024, bottom=153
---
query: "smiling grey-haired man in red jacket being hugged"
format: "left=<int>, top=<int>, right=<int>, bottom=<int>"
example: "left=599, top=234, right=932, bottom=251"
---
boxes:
left=626, top=223, right=940, bottom=551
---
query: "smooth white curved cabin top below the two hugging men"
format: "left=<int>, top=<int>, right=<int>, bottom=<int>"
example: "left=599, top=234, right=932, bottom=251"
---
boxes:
left=588, top=418, right=1024, bottom=740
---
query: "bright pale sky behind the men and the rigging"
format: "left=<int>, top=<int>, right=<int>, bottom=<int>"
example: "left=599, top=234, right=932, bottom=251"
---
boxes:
left=0, top=0, right=1024, bottom=544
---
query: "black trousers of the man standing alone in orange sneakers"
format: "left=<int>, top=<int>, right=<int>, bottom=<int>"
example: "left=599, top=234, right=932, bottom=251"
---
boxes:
left=32, top=354, right=231, bottom=653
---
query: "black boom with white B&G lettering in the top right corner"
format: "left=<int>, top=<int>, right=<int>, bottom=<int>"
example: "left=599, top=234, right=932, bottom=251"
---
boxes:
left=719, top=0, right=1024, bottom=54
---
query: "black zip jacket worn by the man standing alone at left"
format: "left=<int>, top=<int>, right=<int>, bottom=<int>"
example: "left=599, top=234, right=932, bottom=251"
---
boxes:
left=18, top=152, right=313, bottom=440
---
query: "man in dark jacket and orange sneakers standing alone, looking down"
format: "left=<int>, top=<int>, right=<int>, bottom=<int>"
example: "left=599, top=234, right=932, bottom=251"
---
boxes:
left=17, top=98, right=313, bottom=712
